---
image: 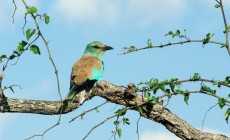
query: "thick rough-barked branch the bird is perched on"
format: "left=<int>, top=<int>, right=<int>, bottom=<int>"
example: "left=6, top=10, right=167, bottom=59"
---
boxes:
left=0, top=81, right=230, bottom=140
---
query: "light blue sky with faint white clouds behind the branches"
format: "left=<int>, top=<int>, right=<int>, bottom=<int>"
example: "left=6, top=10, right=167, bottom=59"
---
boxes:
left=0, top=0, right=230, bottom=140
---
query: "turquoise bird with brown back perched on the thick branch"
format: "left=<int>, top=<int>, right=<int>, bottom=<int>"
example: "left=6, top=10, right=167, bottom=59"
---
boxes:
left=66, top=41, right=113, bottom=101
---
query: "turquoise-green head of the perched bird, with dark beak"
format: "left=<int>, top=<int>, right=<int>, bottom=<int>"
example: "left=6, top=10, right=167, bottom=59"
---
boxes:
left=83, top=41, right=113, bottom=59
